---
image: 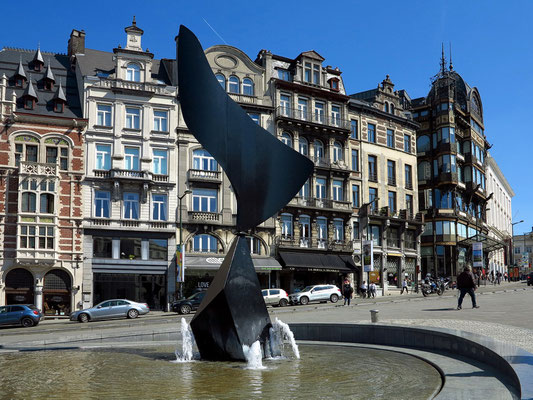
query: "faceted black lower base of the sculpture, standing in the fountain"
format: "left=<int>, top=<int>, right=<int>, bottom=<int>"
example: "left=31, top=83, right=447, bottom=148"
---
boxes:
left=191, top=234, right=279, bottom=361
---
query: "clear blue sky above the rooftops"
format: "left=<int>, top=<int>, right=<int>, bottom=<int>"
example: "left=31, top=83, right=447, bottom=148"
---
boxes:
left=0, top=0, right=533, bottom=234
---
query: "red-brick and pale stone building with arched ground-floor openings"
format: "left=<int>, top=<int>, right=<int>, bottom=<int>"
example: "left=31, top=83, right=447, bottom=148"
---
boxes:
left=0, top=48, right=86, bottom=315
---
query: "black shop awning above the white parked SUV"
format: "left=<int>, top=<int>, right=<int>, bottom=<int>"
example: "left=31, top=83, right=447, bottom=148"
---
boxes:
left=279, top=251, right=355, bottom=272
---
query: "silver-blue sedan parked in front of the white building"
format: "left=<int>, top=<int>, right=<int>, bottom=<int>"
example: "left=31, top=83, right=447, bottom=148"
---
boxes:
left=70, top=299, right=150, bottom=322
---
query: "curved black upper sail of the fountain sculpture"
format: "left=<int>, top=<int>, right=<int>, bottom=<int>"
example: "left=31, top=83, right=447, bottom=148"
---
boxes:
left=178, top=25, right=313, bottom=231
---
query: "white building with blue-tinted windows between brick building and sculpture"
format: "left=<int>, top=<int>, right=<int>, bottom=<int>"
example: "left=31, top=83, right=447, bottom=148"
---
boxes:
left=69, top=19, right=178, bottom=309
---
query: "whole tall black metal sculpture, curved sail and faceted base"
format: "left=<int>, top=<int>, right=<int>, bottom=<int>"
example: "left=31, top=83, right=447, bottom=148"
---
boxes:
left=178, top=25, right=313, bottom=360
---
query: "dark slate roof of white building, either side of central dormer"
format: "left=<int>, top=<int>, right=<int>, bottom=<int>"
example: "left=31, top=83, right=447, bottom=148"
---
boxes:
left=76, top=49, right=172, bottom=85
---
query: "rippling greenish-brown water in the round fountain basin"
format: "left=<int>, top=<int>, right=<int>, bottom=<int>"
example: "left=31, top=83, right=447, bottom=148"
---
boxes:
left=0, top=345, right=441, bottom=400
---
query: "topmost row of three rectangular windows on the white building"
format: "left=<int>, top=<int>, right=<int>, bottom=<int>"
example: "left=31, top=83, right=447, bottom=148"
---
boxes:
left=96, top=104, right=168, bottom=133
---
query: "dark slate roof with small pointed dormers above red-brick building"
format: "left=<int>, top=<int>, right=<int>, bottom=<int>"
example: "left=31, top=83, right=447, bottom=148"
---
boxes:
left=0, top=48, right=83, bottom=118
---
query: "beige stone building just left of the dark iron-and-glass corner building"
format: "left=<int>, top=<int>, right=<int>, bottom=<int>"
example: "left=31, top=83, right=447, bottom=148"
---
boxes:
left=348, top=75, right=423, bottom=288
